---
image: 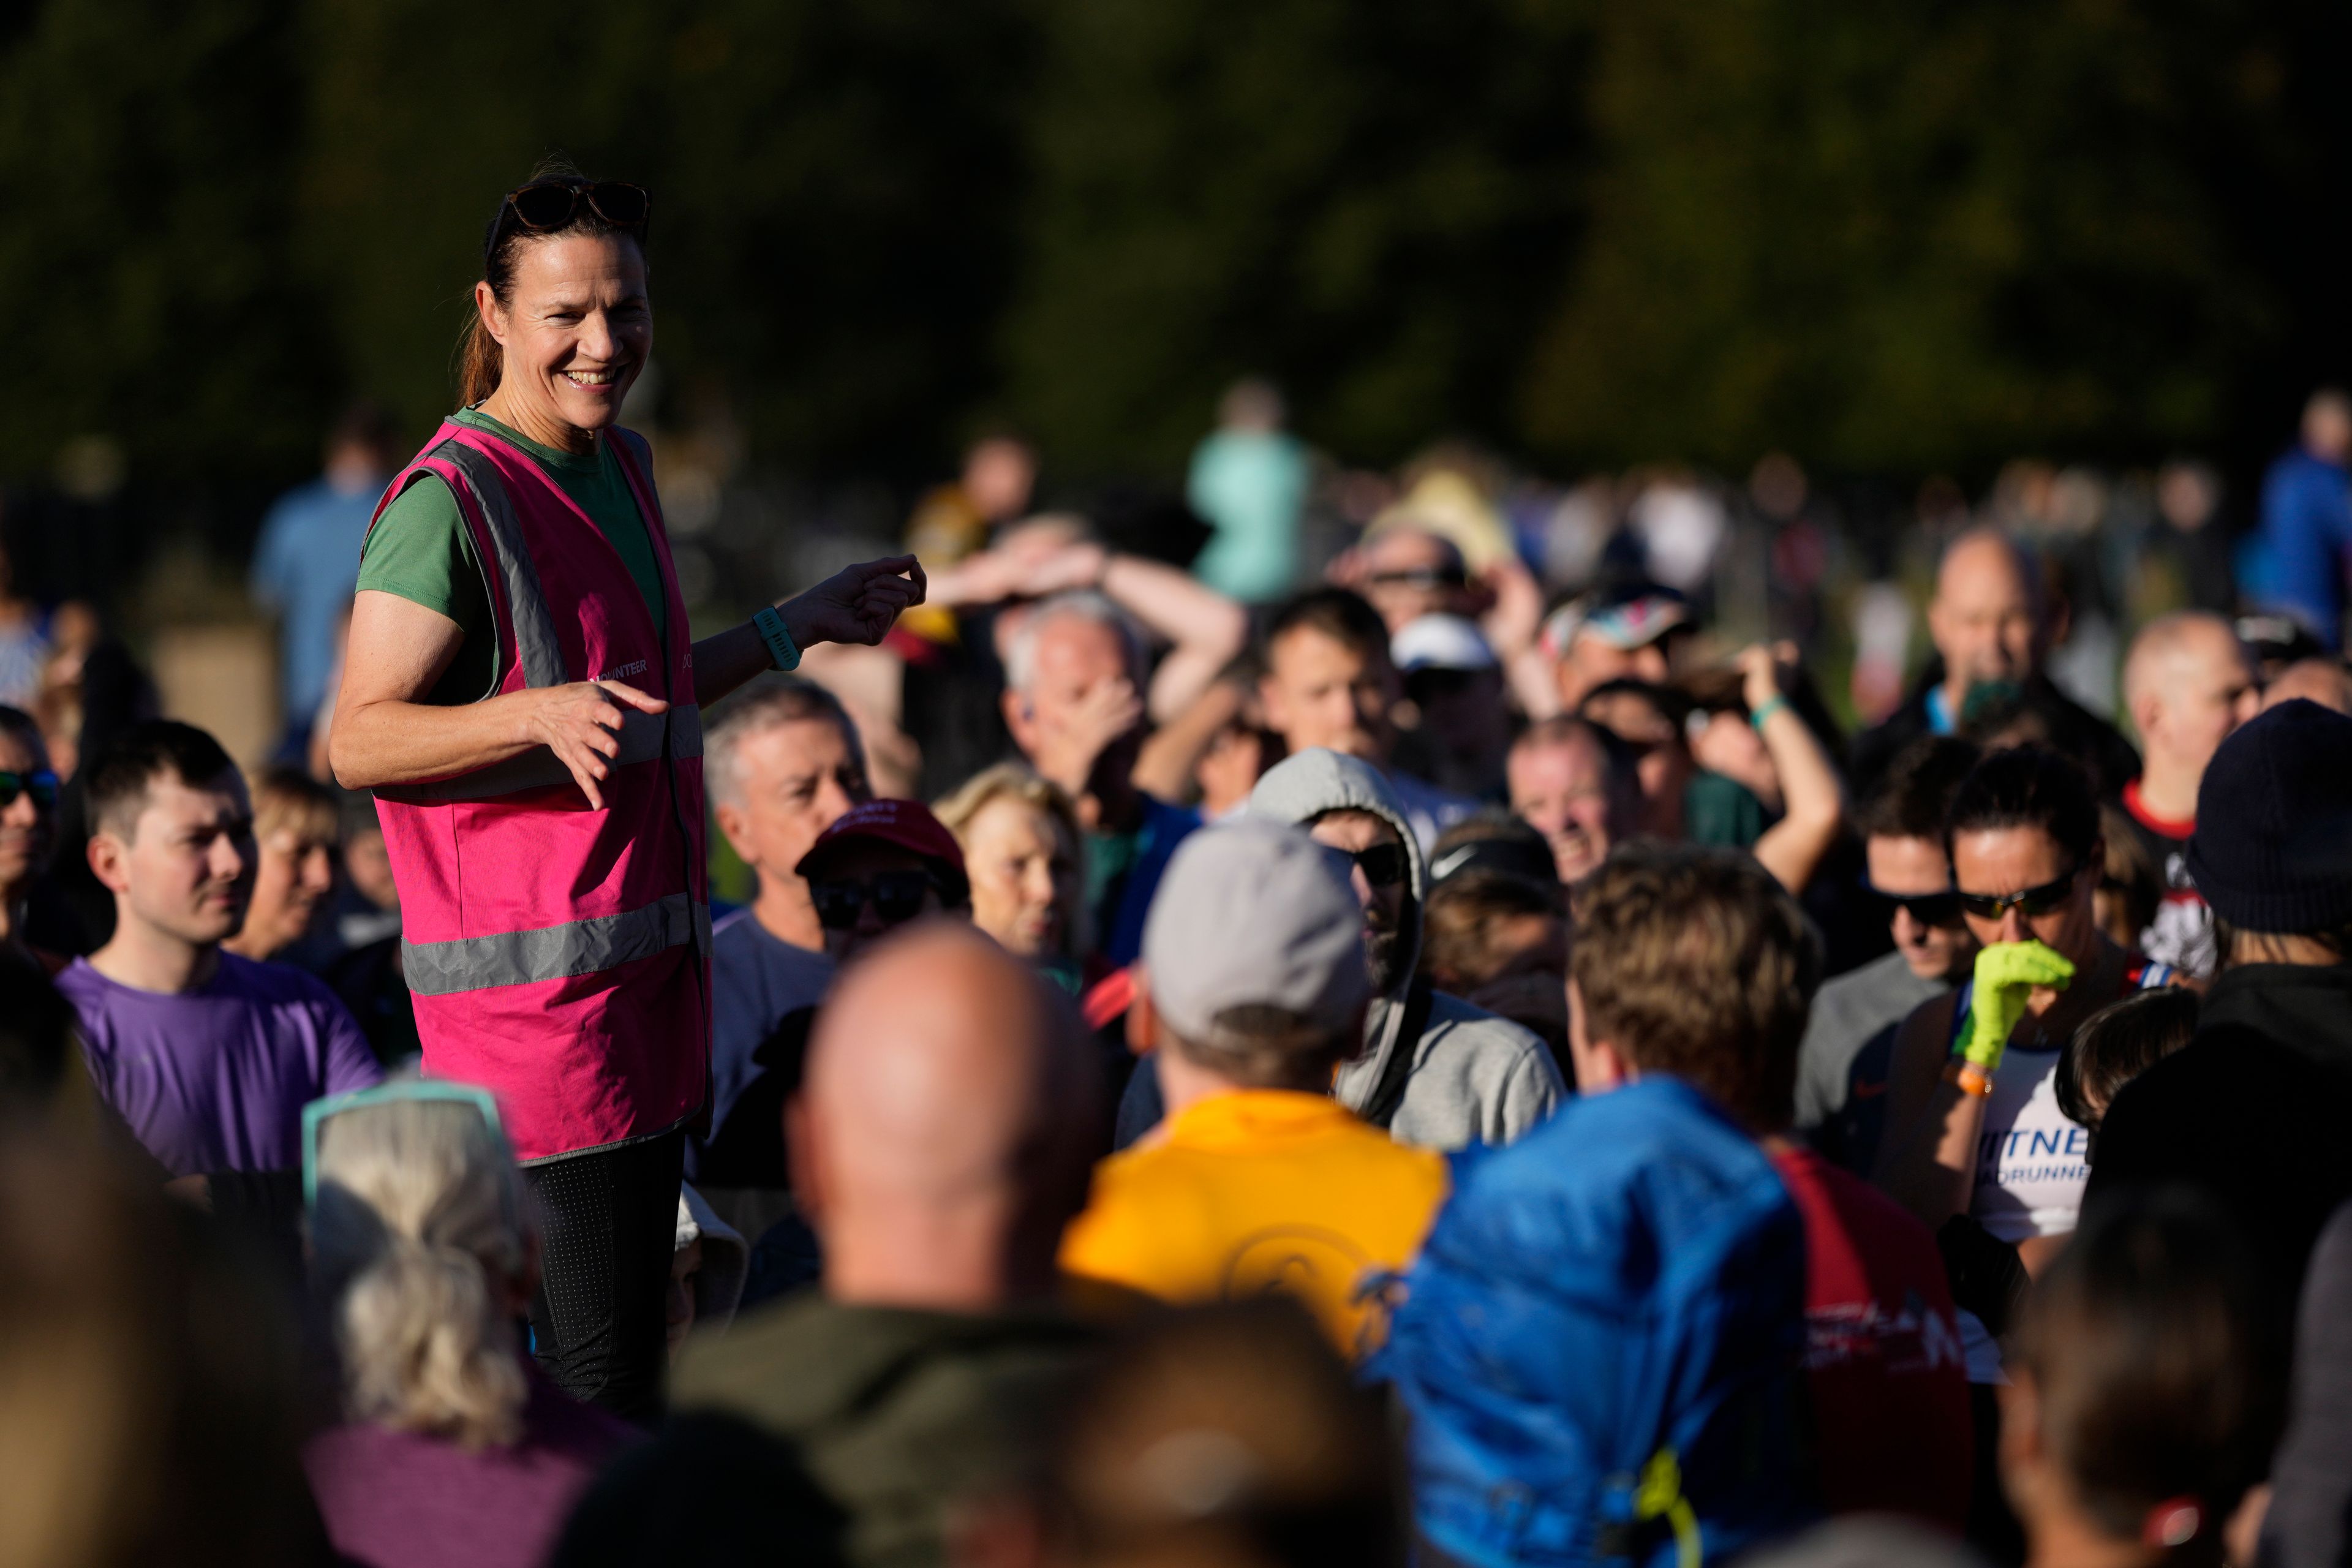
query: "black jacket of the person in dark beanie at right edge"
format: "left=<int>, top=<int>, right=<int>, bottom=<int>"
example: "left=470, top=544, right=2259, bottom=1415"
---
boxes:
left=2084, top=964, right=2352, bottom=1312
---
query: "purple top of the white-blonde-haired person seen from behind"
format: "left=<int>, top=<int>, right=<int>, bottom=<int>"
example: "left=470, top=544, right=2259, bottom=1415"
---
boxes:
left=301, top=1366, right=638, bottom=1568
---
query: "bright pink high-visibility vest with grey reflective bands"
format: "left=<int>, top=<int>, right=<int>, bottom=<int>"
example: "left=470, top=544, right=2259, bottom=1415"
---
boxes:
left=369, top=423, right=710, bottom=1159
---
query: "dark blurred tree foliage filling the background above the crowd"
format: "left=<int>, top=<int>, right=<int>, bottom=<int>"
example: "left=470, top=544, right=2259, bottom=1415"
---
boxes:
left=0, top=0, right=2352, bottom=496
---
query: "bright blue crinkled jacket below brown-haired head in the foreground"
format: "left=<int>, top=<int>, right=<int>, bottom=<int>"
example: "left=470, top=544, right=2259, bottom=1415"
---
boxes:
left=1369, top=1079, right=1818, bottom=1568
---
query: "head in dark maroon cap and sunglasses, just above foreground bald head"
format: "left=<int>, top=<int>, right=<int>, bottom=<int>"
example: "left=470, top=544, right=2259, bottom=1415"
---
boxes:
left=797, top=799, right=971, bottom=966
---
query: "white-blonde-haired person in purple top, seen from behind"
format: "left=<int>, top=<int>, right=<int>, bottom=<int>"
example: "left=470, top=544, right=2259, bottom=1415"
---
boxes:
left=301, top=1079, right=639, bottom=1568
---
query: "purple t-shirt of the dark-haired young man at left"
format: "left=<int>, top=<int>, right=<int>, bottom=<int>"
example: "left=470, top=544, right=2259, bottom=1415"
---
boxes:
left=56, top=952, right=383, bottom=1175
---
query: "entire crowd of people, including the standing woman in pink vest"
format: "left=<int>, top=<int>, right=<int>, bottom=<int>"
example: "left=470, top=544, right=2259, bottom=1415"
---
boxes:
left=0, top=172, right=2352, bottom=1568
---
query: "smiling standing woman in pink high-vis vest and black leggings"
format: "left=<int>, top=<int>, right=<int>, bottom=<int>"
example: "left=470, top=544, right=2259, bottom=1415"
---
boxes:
left=327, top=169, right=922, bottom=1420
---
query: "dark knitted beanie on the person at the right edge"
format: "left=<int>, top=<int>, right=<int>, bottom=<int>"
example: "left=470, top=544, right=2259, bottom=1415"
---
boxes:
left=2190, top=698, right=2352, bottom=936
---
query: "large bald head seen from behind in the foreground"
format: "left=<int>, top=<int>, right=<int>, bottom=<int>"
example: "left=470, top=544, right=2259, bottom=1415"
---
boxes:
left=790, top=922, right=1096, bottom=1312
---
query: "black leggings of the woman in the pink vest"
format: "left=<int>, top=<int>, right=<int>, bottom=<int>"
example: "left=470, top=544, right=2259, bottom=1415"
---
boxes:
left=522, top=1133, right=687, bottom=1425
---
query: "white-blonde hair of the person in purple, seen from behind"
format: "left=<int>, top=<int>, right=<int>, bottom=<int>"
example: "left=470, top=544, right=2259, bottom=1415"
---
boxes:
left=311, top=1100, right=529, bottom=1448
